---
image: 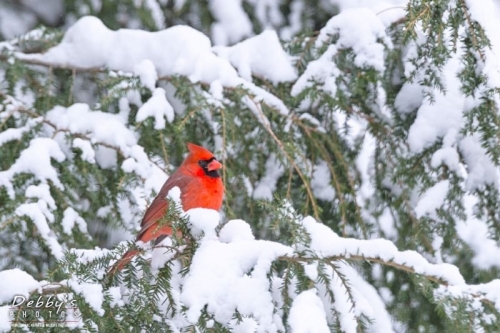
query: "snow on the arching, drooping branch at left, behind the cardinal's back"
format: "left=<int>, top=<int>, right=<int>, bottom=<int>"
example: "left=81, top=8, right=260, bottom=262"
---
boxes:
left=0, top=92, right=167, bottom=259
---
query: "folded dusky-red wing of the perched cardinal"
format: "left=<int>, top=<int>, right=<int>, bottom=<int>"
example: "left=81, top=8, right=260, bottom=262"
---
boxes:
left=137, top=172, right=191, bottom=242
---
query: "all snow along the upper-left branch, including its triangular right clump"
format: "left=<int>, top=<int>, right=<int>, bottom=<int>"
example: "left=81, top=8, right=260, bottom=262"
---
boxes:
left=0, top=16, right=297, bottom=117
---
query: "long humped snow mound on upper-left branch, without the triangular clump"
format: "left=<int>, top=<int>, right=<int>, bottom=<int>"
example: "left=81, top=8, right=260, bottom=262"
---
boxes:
left=17, top=16, right=237, bottom=85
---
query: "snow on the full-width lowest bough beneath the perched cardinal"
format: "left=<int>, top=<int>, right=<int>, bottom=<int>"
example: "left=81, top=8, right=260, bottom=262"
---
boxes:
left=0, top=208, right=500, bottom=332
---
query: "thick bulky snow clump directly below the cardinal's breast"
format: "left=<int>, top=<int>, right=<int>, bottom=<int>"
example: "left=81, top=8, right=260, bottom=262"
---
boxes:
left=180, top=218, right=291, bottom=332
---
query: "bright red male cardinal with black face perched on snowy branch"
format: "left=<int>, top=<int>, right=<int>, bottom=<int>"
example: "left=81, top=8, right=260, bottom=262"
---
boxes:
left=112, top=143, right=224, bottom=272
